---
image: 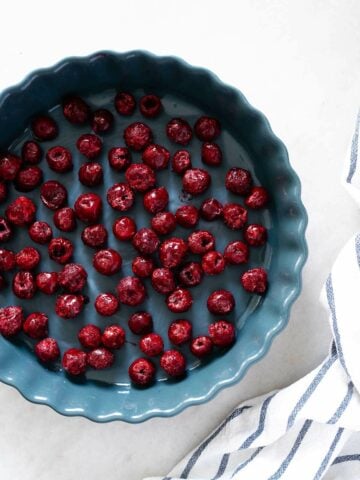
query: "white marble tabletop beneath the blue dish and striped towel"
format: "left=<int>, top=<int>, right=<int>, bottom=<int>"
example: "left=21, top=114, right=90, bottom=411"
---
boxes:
left=0, top=0, right=360, bottom=480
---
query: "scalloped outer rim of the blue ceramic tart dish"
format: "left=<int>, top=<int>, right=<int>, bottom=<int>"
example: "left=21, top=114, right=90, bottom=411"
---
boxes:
left=0, top=50, right=308, bottom=423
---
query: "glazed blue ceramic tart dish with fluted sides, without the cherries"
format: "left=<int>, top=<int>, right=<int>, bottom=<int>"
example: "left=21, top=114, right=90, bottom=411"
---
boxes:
left=0, top=52, right=307, bottom=422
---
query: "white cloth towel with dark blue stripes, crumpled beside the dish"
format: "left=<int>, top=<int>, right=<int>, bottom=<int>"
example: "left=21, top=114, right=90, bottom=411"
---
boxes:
left=147, top=110, right=360, bottom=480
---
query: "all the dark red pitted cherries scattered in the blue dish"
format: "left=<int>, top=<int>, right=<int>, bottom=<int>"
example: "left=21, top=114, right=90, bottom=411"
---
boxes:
left=0, top=92, right=269, bottom=385
